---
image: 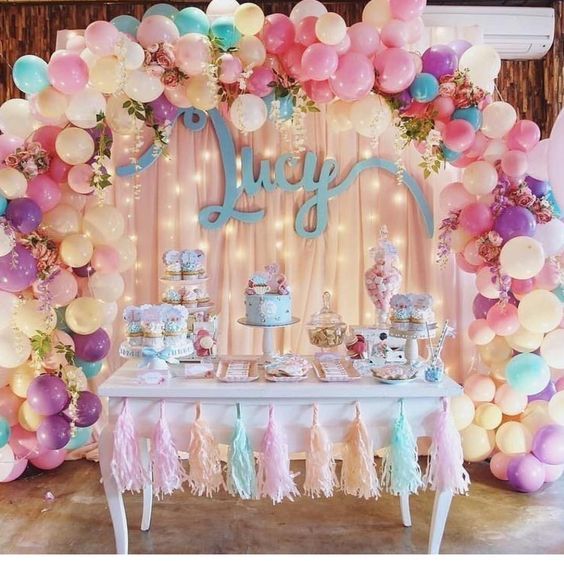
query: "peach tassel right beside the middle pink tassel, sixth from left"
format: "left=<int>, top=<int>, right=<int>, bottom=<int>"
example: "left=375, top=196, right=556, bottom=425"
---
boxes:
left=304, top=403, right=337, bottom=498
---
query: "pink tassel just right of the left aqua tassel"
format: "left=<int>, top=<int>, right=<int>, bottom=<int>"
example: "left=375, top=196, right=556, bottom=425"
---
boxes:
left=258, top=405, right=300, bottom=504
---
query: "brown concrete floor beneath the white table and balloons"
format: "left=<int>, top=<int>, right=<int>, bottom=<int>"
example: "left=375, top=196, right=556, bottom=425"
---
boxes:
left=0, top=461, right=564, bottom=554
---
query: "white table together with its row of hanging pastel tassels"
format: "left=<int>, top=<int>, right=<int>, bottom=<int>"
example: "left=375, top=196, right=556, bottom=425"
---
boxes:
left=99, top=357, right=469, bottom=553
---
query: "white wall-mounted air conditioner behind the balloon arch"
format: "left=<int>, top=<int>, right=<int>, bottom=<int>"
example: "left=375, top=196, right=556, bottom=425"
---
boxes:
left=423, top=6, right=554, bottom=60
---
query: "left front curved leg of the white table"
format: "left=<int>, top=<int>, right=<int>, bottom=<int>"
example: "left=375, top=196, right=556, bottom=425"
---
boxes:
left=98, top=425, right=127, bottom=555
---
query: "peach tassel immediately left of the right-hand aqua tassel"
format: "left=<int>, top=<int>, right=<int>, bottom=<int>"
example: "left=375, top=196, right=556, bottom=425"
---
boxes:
left=341, top=402, right=380, bottom=499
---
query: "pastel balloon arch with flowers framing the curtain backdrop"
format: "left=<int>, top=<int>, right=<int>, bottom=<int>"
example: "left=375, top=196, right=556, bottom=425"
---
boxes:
left=0, top=0, right=564, bottom=491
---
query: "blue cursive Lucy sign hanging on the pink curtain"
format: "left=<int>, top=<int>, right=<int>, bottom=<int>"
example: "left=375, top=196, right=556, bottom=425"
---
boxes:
left=113, top=108, right=433, bottom=238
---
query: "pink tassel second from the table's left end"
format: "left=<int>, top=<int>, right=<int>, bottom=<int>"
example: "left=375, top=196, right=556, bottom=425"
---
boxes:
left=151, top=401, right=186, bottom=497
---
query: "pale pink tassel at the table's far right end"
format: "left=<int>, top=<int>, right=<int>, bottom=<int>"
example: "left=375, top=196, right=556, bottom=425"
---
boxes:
left=425, top=398, right=470, bottom=495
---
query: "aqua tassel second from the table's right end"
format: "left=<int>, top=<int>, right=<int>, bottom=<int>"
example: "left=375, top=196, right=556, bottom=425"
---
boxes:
left=382, top=399, right=423, bottom=495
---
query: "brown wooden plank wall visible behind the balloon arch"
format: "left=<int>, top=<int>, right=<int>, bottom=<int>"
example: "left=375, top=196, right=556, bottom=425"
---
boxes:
left=0, top=0, right=564, bottom=136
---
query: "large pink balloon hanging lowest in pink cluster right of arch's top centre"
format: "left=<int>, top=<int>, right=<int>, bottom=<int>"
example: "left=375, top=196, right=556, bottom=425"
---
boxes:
left=329, top=52, right=374, bottom=101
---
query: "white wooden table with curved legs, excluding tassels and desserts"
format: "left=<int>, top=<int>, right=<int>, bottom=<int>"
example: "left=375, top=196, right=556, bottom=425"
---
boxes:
left=98, top=357, right=462, bottom=554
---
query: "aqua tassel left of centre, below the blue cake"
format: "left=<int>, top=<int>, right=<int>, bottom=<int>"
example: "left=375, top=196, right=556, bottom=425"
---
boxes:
left=227, top=403, right=257, bottom=499
